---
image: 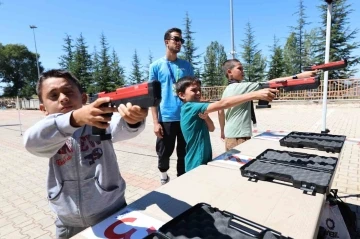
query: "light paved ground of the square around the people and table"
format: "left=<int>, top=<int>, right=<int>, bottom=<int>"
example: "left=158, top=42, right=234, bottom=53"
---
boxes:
left=0, top=103, right=360, bottom=238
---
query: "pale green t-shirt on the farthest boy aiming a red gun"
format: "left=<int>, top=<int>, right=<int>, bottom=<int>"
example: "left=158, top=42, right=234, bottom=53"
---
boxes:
left=222, top=82, right=261, bottom=138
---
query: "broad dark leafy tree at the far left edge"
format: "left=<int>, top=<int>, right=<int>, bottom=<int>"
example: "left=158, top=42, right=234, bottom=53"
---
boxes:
left=0, top=44, right=44, bottom=97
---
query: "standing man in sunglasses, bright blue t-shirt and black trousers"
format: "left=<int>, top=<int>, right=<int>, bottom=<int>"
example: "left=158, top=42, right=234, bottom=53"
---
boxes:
left=149, top=28, right=194, bottom=184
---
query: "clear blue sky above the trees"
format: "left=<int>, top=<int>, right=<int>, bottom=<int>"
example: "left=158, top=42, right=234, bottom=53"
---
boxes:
left=0, top=0, right=360, bottom=93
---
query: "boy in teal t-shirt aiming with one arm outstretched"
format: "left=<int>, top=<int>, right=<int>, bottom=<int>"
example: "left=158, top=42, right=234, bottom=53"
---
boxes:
left=176, top=77, right=278, bottom=172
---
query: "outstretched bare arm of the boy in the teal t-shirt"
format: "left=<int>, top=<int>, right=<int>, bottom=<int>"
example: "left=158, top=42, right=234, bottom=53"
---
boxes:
left=204, top=89, right=278, bottom=113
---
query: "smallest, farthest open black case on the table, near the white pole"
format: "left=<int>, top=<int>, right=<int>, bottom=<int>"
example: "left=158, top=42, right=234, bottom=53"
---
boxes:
left=280, top=131, right=346, bottom=153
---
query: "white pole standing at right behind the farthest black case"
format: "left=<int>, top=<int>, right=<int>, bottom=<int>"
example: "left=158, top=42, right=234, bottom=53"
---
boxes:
left=321, top=0, right=333, bottom=134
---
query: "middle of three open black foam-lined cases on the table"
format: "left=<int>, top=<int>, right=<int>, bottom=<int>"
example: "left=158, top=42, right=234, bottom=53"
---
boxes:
left=240, top=149, right=338, bottom=195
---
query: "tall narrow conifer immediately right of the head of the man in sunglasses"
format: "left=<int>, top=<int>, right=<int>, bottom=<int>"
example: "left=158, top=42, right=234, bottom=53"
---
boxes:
left=179, top=12, right=200, bottom=69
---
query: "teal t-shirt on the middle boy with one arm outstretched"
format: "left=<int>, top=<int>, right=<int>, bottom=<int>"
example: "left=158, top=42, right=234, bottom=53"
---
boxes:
left=180, top=102, right=212, bottom=172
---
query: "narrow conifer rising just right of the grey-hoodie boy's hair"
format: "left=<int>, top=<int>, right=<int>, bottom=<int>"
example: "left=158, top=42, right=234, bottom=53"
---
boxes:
left=71, top=33, right=92, bottom=93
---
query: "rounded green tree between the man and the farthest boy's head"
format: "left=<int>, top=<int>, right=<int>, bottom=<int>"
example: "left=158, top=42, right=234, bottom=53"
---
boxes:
left=202, top=41, right=227, bottom=86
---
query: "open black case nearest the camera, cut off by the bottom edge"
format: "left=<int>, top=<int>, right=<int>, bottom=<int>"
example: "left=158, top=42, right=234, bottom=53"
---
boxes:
left=159, top=203, right=288, bottom=239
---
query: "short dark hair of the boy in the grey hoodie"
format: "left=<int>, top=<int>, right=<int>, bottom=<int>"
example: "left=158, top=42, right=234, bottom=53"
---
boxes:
left=36, top=69, right=84, bottom=103
